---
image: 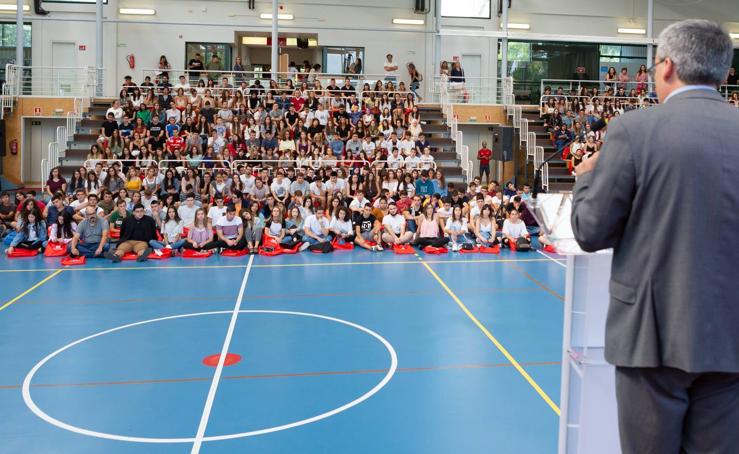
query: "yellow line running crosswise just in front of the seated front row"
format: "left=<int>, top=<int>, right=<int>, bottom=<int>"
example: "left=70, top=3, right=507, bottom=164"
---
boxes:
left=0, top=259, right=549, bottom=273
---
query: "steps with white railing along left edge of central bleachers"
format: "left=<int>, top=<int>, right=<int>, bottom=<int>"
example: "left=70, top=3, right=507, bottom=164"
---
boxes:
left=59, top=98, right=113, bottom=177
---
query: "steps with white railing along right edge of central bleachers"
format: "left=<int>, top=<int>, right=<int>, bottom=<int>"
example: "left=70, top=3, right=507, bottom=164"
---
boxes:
left=418, top=104, right=465, bottom=186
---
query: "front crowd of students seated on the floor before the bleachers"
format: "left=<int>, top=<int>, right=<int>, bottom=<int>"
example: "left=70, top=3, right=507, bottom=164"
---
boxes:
left=0, top=168, right=546, bottom=262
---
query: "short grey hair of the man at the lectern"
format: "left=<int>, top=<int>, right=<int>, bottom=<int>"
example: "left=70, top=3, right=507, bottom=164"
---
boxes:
left=657, top=19, right=734, bottom=86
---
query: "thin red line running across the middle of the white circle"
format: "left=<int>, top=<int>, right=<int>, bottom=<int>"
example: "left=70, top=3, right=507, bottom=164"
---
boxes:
left=0, top=361, right=560, bottom=389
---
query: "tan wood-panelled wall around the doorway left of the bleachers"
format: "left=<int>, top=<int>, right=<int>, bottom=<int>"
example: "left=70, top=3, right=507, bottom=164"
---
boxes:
left=2, top=98, right=74, bottom=184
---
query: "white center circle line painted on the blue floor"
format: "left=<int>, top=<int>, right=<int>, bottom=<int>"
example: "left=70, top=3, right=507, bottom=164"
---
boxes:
left=21, top=310, right=398, bottom=443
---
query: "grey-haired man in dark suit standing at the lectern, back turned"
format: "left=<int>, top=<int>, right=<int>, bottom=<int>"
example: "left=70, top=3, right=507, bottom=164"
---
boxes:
left=572, top=20, right=739, bottom=454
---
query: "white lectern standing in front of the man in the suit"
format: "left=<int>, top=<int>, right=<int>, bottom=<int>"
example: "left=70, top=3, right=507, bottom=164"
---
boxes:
left=526, top=193, right=621, bottom=454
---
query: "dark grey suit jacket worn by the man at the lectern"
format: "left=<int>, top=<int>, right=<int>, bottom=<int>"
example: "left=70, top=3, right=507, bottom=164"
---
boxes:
left=572, top=90, right=739, bottom=373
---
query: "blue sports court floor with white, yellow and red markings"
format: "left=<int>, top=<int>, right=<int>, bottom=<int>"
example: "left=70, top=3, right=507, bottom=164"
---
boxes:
left=0, top=250, right=565, bottom=454
